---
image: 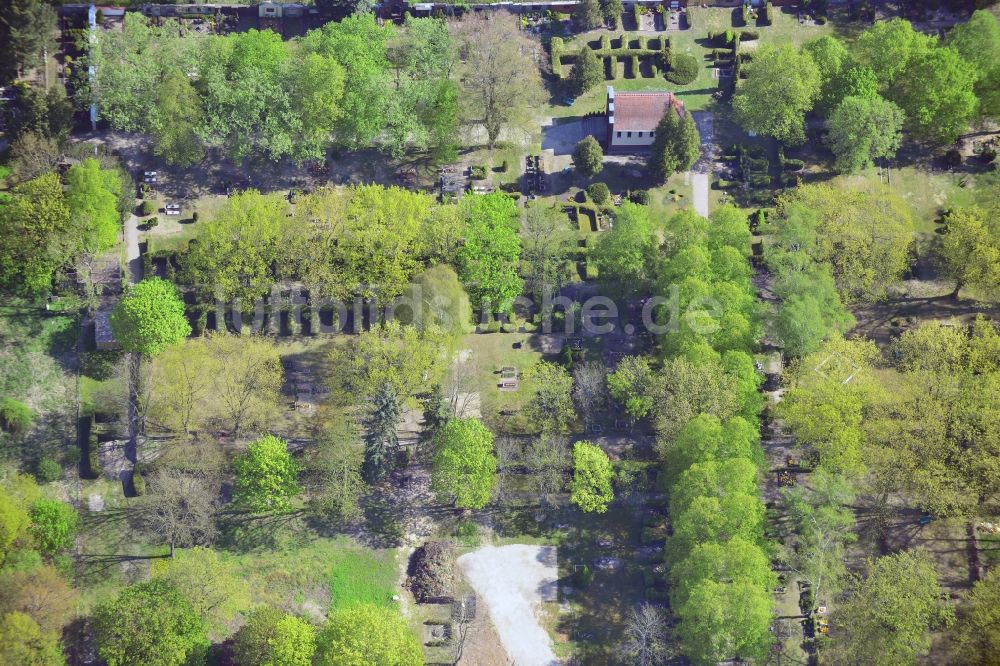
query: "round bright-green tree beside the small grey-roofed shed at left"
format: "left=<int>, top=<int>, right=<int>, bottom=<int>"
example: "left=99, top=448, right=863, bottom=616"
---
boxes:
left=111, top=277, right=191, bottom=356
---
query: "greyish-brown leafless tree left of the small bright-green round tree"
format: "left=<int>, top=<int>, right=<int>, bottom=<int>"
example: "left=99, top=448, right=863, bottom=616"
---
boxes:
left=137, top=469, right=219, bottom=557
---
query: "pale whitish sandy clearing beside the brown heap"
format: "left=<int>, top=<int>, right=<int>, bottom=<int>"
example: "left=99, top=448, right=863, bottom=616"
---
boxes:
left=458, top=545, right=559, bottom=666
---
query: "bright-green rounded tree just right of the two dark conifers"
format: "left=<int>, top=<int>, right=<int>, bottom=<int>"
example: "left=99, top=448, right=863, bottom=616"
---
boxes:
left=431, top=418, right=497, bottom=509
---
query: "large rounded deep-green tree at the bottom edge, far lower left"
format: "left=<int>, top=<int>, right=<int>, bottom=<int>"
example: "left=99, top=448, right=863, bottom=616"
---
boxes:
left=94, top=579, right=208, bottom=666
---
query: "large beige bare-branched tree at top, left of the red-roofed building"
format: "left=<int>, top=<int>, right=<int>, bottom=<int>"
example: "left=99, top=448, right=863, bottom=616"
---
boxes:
left=453, top=12, right=545, bottom=149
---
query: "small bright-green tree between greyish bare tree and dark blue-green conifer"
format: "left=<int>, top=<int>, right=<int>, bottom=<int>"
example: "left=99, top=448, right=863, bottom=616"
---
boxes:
left=234, top=435, right=302, bottom=513
